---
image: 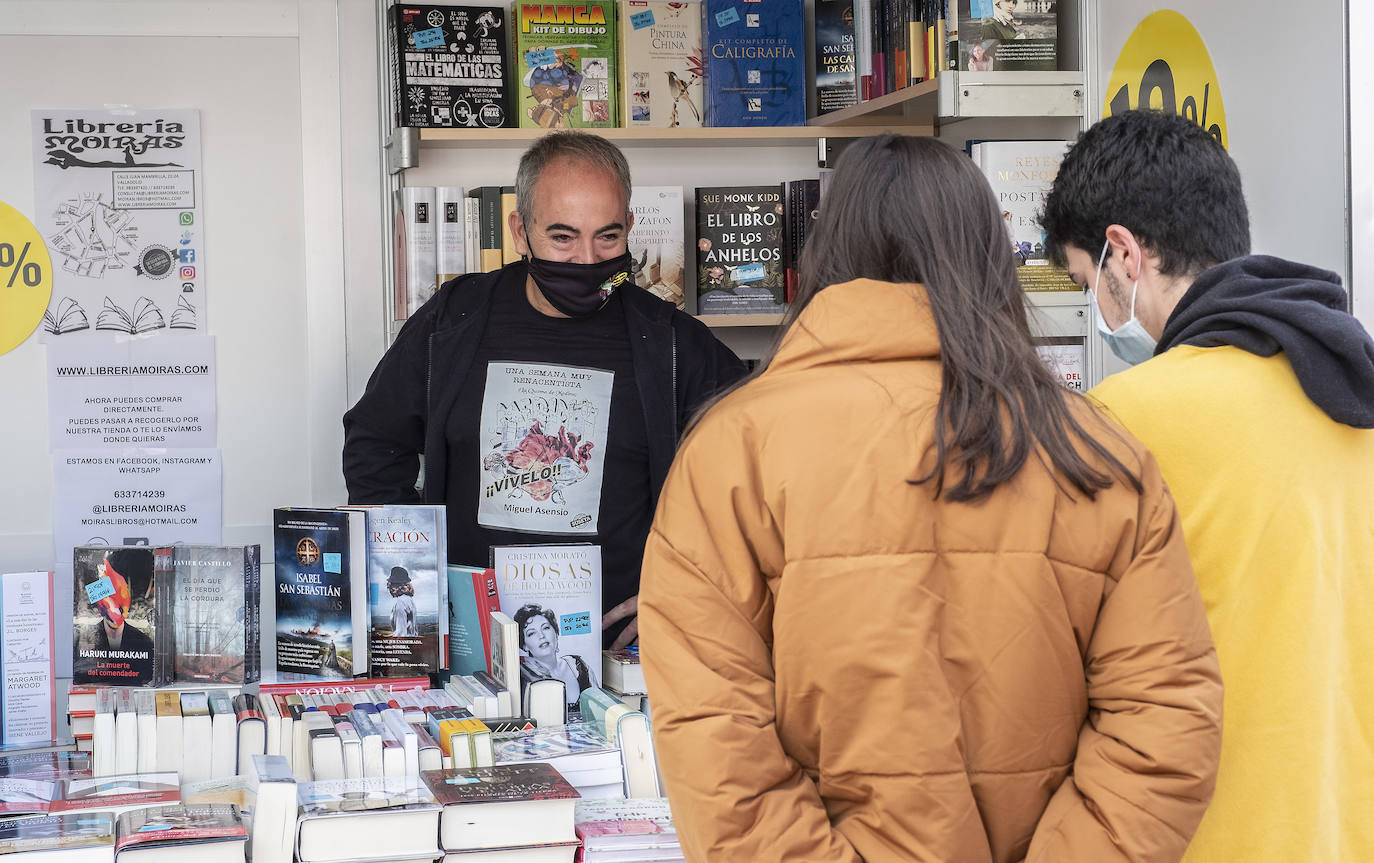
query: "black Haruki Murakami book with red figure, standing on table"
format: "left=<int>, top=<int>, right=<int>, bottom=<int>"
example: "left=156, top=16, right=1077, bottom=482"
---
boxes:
left=71, top=546, right=160, bottom=686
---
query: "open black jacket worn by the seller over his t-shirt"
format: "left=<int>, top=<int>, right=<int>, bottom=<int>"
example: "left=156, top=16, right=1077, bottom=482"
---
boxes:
left=344, top=262, right=745, bottom=503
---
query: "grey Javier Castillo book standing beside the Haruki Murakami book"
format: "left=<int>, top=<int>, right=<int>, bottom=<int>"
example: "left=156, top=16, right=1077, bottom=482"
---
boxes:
left=165, top=544, right=261, bottom=686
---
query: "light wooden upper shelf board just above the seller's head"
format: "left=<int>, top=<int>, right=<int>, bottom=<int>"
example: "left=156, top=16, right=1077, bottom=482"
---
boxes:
left=419, top=118, right=934, bottom=147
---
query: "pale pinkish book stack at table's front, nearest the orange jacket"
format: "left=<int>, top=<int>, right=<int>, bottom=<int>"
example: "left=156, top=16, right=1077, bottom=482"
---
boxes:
left=573, top=797, right=684, bottom=863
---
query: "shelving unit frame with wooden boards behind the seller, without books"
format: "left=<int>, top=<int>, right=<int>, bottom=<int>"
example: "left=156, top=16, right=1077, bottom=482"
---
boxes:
left=378, top=0, right=1102, bottom=383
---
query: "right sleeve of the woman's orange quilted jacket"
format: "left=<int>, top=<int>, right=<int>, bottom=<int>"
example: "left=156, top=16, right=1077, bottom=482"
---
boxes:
left=1026, top=456, right=1221, bottom=863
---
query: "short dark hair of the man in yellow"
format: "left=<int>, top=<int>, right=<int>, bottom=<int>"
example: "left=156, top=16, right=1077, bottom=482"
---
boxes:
left=1040, top=111, right=1250, bottom=276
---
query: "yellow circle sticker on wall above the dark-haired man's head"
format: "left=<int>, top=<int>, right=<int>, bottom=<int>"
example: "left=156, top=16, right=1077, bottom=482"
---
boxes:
left=1102, top=10, right=1230, bottom=147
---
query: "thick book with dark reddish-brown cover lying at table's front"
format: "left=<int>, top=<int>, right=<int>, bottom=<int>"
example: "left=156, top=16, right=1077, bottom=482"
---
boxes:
left=422, top=764, right=578, bottom=863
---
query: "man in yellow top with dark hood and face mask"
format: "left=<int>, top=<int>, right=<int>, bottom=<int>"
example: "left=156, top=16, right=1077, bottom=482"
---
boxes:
left=1043, top=111, right=1374, bottom=863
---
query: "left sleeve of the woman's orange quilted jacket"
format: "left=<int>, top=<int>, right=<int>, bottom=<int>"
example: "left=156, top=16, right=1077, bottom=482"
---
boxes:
left=639, top=418, right=859, bottom=863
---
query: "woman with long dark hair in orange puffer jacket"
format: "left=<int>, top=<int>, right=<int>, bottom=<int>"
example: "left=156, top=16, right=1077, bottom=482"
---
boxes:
left=639, top=135, right=1221, bottom=863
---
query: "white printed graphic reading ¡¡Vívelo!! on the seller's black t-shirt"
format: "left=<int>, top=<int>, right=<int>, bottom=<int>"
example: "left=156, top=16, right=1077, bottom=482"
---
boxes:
left=477, top=363, right=616, bottom=533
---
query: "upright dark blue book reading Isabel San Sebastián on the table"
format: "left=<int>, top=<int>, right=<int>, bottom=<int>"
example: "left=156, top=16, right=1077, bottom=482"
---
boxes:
left=272, top=508, right=367, bottom=680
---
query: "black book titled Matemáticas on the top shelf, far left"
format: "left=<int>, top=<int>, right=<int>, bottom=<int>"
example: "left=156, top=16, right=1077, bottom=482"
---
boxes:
left=386, top=3, right=510, bottom=129
